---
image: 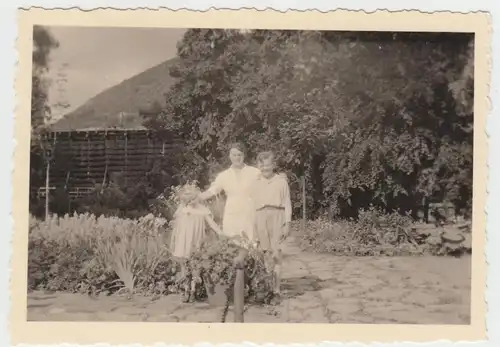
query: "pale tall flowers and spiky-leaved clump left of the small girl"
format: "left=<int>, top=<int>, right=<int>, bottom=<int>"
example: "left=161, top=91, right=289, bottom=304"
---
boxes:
left=30, top=214, right=174, bottom=293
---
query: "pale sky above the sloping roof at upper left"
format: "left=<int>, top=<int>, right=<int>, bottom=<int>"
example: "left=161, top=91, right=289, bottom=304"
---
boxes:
left=48, top=27, right=185, bottom=119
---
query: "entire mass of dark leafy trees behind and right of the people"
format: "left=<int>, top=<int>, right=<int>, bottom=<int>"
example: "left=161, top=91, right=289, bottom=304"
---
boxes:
left=146, top=29, right=473, bottom=217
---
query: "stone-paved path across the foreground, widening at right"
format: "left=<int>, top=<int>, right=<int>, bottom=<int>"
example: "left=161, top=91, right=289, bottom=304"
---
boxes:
left=28, top=240, right=471, bottom=324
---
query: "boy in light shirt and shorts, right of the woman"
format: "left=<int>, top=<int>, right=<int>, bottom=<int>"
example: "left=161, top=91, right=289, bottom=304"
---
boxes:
left=253, top=152, right=292, bottom=297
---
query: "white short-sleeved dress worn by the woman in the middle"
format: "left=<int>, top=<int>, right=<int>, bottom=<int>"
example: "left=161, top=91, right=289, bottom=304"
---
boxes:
left=209, top=165, right=260, bottom=240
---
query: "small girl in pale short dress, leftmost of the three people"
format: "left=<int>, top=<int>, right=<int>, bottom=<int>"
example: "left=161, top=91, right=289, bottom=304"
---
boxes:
left=170, top=185, right=222, bottom=301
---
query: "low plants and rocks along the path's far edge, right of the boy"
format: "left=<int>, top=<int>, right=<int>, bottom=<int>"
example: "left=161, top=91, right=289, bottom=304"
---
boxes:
left=292, top=207, right=471, bottom=256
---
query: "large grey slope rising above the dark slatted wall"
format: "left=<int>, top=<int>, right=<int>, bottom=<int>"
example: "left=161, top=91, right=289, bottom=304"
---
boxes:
left=52, top=58, right=176, bottom=131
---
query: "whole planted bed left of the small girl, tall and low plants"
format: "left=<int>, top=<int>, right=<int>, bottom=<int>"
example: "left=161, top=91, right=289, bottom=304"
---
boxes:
left=28, top=214, right=175, bottom=294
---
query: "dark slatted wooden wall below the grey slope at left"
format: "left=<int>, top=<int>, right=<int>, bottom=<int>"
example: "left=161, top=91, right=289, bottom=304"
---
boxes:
left=31, top=129, right=180, bottom=198
